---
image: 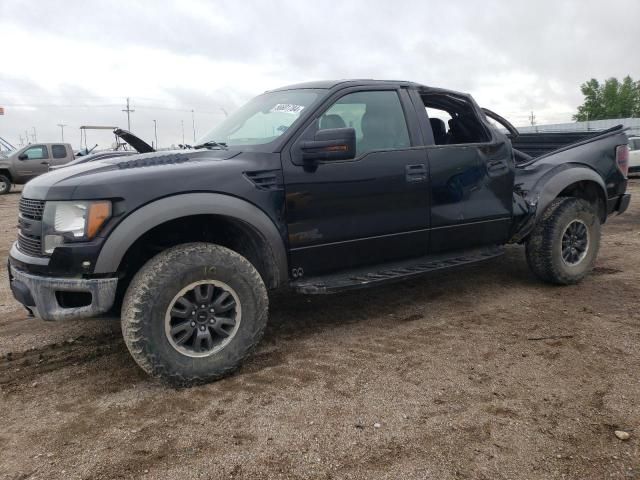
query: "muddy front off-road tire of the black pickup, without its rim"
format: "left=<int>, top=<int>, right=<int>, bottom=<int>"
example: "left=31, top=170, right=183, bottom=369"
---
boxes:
left=122, top=243, right=269, bottom=386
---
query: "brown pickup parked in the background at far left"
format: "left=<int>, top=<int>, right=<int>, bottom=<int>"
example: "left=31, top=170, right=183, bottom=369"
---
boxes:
left=0, top=143, right=74, bottom=195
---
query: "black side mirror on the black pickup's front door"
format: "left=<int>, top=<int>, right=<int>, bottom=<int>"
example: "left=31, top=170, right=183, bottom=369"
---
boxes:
left=300, top=128, right=356, bottom=161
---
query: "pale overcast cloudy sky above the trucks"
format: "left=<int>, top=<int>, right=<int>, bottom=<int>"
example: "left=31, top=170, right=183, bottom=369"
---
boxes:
left=0, top=0, right=640, bottom=147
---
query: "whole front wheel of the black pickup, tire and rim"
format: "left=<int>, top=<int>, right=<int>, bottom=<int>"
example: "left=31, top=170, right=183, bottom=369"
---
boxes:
left=122, top=243, right=268, bottom=386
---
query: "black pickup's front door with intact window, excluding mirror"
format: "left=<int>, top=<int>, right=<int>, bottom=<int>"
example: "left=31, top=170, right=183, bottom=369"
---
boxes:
left=283, top=88, right=429, bottom=276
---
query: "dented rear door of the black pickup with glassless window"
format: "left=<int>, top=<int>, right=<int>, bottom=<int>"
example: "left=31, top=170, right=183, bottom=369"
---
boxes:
left=421, top=93, right=515, bottom=253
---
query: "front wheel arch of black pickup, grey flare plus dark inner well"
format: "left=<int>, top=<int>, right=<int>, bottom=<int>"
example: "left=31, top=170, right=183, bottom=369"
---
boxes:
left=94, top=193, right=288, bottom=288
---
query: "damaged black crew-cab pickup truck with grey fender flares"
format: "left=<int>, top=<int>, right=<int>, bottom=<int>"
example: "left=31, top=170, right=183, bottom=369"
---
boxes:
left=9, top=80, right=629, bottom=385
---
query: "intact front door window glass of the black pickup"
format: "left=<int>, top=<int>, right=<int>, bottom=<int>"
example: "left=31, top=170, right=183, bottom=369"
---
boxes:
left=318, top=90, right=411, bottom=156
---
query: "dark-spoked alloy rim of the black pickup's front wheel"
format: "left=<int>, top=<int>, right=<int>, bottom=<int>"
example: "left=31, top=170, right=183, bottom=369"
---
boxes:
left=164, top=280, right=242, bottom=357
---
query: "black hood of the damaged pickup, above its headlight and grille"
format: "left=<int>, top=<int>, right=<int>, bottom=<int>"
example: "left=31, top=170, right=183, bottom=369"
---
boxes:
left=22, top=150, right=241, bottom=200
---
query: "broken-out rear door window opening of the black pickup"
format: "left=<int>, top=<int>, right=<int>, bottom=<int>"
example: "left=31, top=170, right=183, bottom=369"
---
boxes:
left=422, top=93, right=489, bottom=145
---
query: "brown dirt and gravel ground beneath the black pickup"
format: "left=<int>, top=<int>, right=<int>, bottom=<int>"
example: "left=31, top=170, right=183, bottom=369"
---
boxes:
left=0, top=181, right=640, bottom=480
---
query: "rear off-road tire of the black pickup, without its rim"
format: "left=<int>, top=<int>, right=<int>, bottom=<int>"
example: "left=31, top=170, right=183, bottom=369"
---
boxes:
left=526, top=197, right=601, bottom=285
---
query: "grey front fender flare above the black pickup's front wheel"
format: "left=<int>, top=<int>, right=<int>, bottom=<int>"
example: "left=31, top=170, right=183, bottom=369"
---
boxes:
left=94, top=193, right=288, bottom=284
